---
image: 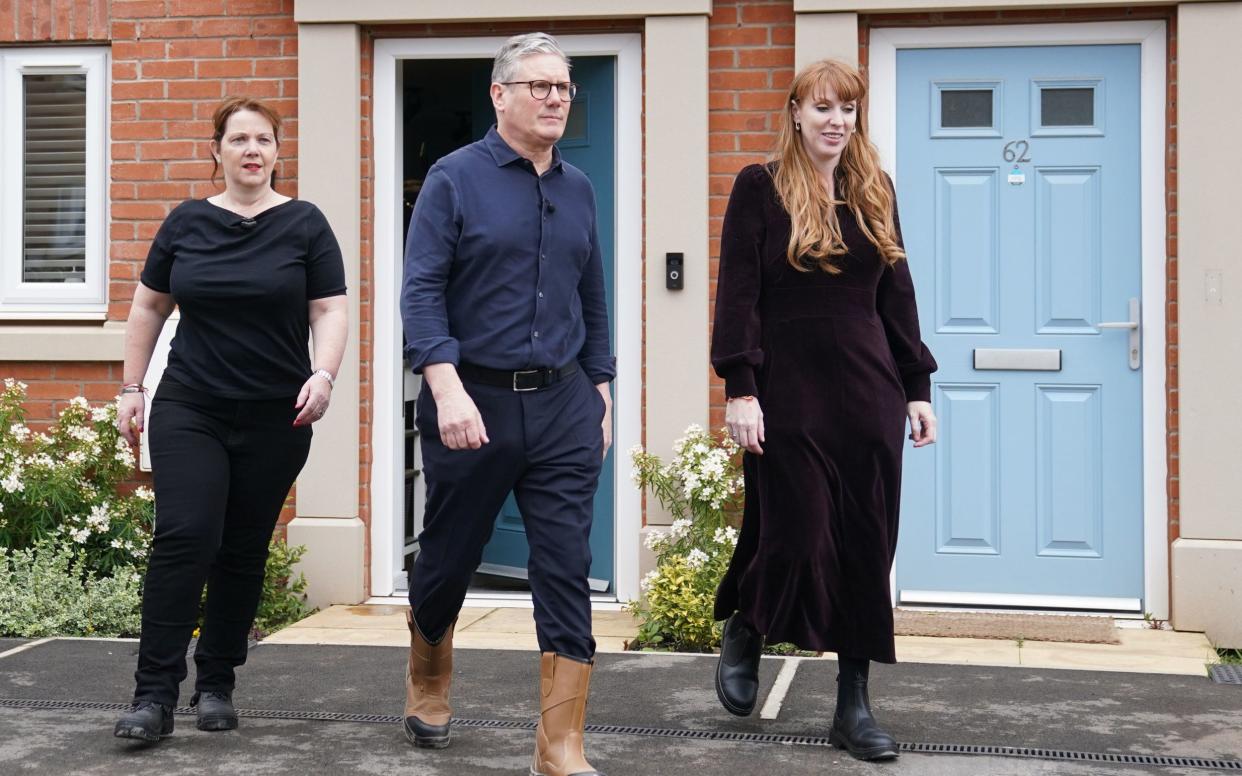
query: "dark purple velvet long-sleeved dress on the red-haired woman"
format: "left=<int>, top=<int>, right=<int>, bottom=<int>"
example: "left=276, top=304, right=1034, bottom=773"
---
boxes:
left=712, top=165, right=936, bottom=663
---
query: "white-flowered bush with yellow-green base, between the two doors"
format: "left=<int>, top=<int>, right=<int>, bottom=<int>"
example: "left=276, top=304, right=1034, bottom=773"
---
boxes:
left=628, top=425, right=743, bottom=652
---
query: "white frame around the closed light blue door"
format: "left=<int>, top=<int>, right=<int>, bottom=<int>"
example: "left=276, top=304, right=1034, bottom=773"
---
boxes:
left=868, top=21, right=1169, bottom=620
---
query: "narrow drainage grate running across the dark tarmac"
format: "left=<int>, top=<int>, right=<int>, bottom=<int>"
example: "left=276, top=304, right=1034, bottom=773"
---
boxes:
left=0, top=698, right=1242, bottom=772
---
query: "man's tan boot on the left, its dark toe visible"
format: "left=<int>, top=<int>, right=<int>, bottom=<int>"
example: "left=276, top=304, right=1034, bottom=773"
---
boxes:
left=405, top=610, right=457, bottom=749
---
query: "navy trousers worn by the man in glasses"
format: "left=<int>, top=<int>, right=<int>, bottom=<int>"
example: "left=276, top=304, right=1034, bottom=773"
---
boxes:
left=410, top=371, right=604, bottom=659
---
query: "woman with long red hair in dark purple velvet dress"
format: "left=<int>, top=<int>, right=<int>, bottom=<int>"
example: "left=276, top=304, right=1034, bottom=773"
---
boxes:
left=712, top=61, right=936, bottom=760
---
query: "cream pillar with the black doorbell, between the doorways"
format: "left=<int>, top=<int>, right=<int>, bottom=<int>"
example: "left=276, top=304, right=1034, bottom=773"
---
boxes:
left=640, top=15, right=708, bottom=524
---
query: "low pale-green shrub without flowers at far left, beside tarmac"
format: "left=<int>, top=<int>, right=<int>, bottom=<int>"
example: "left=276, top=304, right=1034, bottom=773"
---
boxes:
left=0, top=543, right=142, bottom=638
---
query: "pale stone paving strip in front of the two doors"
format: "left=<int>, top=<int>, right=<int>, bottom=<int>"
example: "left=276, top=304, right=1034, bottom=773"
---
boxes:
left=265, top=605, right=1215, bottom=675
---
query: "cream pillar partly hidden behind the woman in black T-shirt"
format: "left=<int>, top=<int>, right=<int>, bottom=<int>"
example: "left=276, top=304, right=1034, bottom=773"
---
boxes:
left=288, top=24, right=365, bottom=606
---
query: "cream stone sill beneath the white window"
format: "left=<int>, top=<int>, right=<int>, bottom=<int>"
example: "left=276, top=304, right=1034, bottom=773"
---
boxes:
left=0, top=313, right=125, bottom=361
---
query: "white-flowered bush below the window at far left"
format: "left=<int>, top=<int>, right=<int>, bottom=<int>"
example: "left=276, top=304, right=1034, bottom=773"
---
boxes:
left=0, top=377, right=155, bottom=577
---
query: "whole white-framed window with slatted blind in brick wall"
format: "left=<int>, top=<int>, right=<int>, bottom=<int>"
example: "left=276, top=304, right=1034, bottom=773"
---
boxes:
left=0, top=46, right=109, bottom=319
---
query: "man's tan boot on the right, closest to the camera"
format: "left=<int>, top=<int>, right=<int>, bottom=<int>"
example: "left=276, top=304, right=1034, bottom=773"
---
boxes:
left=530, top=652, right=604, bottom=776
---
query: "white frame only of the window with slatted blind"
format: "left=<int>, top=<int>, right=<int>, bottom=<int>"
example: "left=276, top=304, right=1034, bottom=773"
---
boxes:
left=0, top=46, right=109, bottom=320
